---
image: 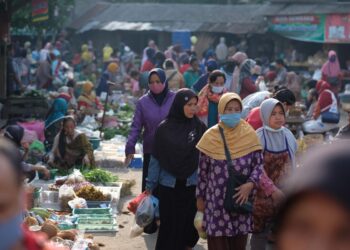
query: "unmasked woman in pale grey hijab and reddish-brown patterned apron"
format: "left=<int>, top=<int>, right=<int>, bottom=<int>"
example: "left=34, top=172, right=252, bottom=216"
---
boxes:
left=250, top=98, right=297, bottom=250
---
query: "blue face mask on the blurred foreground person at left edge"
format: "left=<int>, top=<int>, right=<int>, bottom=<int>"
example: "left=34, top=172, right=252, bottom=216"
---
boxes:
left=0, top=214, right=23, bottom=249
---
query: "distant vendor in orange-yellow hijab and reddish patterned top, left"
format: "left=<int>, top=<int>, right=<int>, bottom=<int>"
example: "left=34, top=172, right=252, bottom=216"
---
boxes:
left=78, top=81, right=103, bottom=115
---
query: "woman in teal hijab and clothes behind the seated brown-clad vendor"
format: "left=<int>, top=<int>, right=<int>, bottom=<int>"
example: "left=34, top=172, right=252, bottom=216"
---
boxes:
left=45, top=98, right=68, bottom=152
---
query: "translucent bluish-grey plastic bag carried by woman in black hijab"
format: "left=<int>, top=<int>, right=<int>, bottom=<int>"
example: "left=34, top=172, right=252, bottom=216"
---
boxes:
left=135, top=196, right=155, bottom=227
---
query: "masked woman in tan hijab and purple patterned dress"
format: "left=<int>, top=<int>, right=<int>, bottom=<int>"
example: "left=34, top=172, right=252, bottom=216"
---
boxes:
left=196, top=93, right=263, bottom=250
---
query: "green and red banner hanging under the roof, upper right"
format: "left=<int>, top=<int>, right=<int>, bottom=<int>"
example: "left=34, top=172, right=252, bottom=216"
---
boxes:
left=269, top=15, right=325, bottom=42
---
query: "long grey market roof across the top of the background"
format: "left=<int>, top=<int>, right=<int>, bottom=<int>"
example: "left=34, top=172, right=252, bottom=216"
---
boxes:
left=69, top=0, right=350, bottom=34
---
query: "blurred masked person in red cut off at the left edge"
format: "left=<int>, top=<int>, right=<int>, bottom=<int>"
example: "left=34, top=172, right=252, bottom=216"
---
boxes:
left=0, top=138, right=57, bottom=250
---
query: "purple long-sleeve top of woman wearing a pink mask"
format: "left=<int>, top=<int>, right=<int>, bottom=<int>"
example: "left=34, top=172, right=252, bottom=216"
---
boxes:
left=125, top=91, right=175, bottom=155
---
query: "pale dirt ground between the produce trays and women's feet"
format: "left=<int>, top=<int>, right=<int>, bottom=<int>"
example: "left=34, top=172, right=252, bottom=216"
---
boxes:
left=95, top=169, right=207, bottom=250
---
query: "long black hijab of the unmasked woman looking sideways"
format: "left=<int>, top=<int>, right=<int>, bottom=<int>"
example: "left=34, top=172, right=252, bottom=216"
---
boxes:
left=153, top=89, right=206, bottom=180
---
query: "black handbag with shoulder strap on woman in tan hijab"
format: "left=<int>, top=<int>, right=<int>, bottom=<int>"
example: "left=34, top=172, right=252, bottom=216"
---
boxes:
left=219, top=127, right=253, bottom=214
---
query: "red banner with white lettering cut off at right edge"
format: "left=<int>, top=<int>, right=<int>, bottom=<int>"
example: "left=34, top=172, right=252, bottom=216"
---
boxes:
left=325, top=14, right=350, bottom=43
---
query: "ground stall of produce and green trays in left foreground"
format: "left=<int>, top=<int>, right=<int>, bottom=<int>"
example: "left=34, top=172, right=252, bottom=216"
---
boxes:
left=24, top=169, right=122, bottom=249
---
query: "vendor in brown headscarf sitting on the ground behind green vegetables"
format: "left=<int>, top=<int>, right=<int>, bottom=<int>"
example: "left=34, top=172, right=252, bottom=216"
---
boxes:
left=48, top=116, right=95, bottom=170
